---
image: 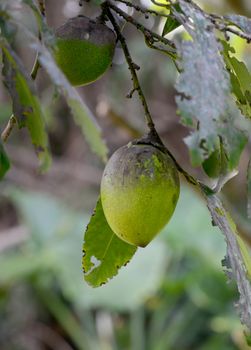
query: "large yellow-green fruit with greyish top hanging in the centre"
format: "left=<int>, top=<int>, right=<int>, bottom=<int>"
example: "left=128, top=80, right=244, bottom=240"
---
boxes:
left=101, top=143, right=180, bottom=247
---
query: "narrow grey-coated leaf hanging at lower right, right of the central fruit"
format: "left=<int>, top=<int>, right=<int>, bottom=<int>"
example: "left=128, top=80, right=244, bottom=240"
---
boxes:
left=206, top=191, right=251, bottom=331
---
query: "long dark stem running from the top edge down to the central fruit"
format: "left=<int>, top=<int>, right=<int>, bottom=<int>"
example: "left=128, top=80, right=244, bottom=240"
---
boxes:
left=103, top=2, right=155, bottom=131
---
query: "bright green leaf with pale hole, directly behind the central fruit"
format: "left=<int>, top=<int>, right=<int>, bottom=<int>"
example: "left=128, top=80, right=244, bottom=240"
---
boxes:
left=83, top=199, right=137, bottom=287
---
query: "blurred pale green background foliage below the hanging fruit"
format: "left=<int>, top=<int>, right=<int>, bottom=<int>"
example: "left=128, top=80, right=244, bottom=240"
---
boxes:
left=0, top=187, right=246, bottom=350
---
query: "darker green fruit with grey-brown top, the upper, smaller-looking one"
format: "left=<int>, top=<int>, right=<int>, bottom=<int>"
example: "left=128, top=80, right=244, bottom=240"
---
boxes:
left=55, top=16, right=116, bottom=86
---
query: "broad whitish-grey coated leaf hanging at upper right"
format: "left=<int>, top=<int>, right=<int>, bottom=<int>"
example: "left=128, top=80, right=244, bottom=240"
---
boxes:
left=176, top=1, right=247, bottom=169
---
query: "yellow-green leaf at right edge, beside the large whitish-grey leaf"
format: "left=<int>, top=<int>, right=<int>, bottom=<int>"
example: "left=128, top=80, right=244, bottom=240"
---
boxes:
left=222, top=41, right=251, bottom=118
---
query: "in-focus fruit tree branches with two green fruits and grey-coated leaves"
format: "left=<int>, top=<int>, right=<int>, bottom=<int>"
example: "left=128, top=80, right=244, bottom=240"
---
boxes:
left=0, top=0, right=251, bottom=340
